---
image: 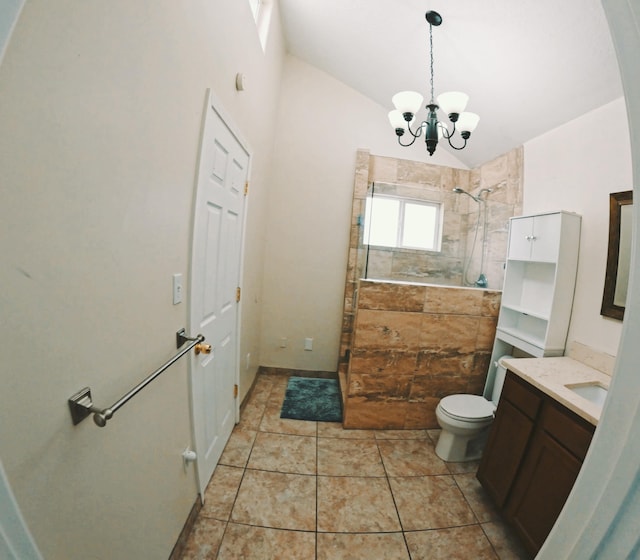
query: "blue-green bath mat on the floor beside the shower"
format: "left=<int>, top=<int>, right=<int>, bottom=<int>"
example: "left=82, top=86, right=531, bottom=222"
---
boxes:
left=280, top=377, right=342, bottom=422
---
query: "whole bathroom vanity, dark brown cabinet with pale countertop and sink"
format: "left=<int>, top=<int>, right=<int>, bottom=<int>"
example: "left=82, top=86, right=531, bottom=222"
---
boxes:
left=477, top=357, right=610, bottom=555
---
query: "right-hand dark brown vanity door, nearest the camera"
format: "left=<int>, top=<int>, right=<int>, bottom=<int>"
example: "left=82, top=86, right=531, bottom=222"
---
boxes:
left=506, top=430, right=582, bottom=553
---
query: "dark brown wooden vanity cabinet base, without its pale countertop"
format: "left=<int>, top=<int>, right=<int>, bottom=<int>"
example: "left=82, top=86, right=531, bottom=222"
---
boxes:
left=477, top=372, right=595, bottom=554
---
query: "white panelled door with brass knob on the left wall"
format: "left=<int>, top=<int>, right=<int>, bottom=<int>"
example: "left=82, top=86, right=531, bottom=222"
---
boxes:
left=190, top=94, right=249, bottom=498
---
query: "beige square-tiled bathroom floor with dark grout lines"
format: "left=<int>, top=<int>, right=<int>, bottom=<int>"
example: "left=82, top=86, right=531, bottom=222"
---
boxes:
left=182, top=373, right=527, bottom=560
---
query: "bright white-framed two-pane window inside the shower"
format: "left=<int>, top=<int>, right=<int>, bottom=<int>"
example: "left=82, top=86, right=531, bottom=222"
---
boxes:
left=364, top=195, right=442, bottom=251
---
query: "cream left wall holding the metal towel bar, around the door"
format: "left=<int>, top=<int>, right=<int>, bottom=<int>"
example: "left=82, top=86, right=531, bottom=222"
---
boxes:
left=0, top=0, right=283, bottom=560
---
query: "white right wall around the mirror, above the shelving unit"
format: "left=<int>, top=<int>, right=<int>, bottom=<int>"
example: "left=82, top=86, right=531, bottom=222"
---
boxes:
left=523, top=98, right=633, bottom=356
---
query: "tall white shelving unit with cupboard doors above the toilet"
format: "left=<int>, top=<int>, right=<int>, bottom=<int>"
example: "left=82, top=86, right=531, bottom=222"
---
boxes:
left=485, top=211, right=581, bottom=396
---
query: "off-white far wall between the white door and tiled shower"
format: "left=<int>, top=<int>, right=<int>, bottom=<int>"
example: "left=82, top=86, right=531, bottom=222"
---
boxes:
left=260, top=56, right=465, bottom=371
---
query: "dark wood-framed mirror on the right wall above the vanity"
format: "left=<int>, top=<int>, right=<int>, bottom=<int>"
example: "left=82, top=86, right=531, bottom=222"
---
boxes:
left=600, top=191, right=633, bottom=320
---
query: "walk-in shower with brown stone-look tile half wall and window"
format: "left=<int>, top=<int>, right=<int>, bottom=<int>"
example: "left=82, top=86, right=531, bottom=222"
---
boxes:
left=338, top=148, right=523, bottom=429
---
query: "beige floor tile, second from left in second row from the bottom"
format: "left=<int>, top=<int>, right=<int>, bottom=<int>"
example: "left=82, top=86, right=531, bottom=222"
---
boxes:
left=231, top=469, right=316, bottom=531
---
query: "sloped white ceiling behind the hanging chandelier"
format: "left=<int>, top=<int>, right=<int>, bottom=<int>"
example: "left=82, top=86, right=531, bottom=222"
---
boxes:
left=280, top=0, right=623, bottom=167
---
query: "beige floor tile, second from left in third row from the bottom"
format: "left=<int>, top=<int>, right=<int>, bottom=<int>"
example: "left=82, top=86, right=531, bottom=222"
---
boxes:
left=247, top=432, right=316, bottom=474
